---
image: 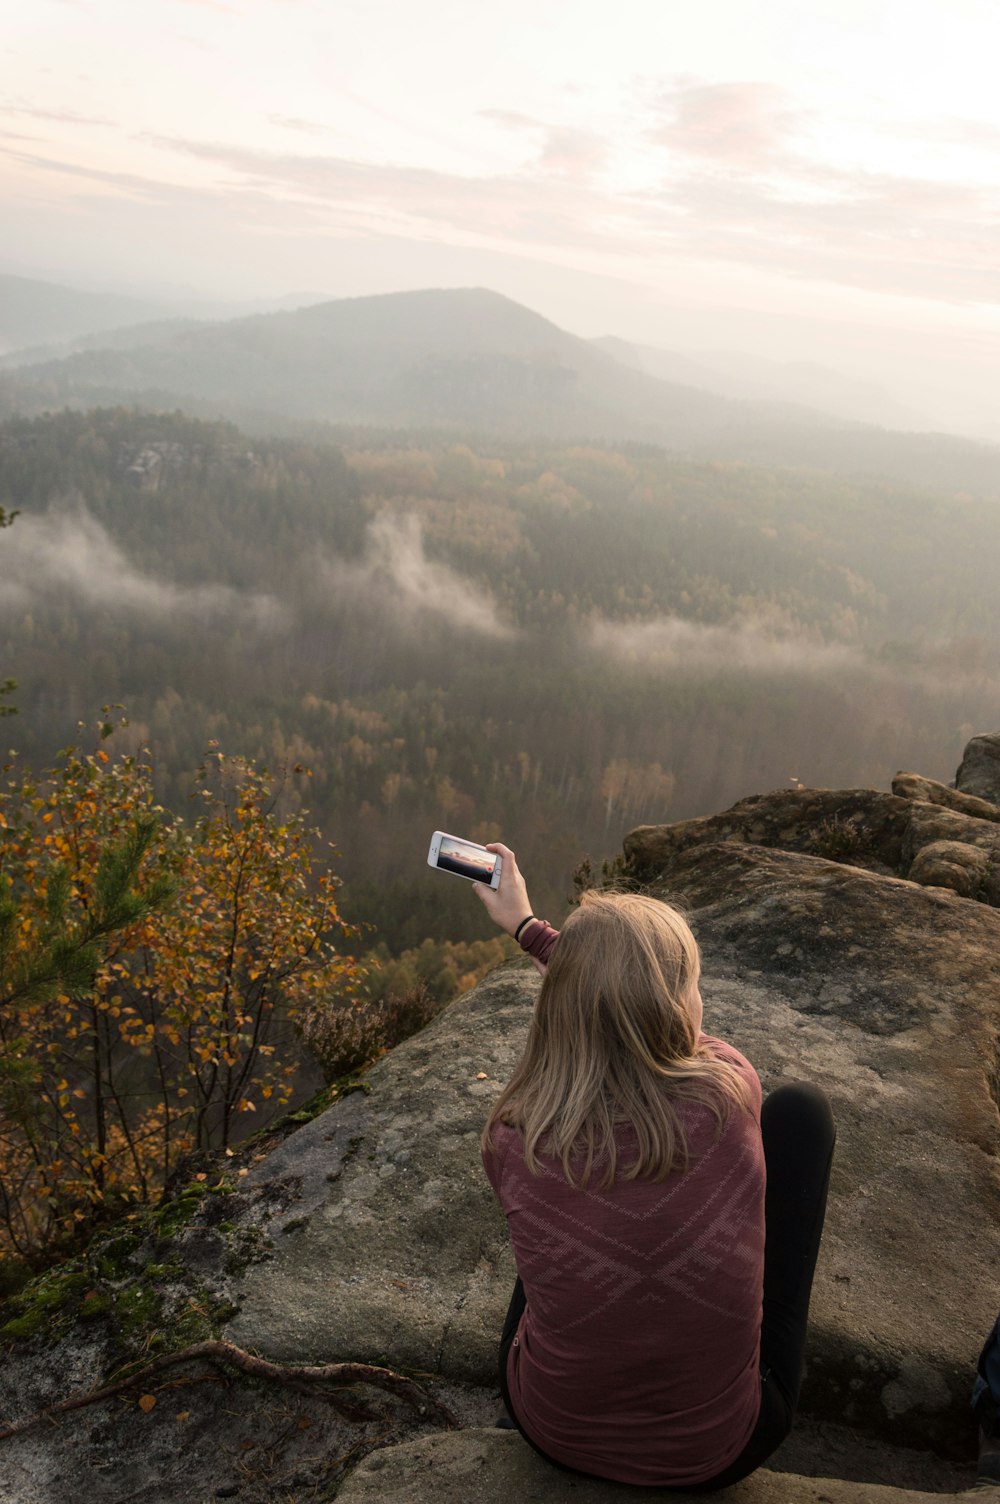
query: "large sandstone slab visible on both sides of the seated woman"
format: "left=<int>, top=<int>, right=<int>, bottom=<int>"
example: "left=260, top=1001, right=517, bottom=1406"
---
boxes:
left=222, top=830, right=1000, bottom=1450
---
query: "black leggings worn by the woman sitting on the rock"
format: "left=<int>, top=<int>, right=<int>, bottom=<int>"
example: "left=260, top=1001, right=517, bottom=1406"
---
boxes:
left=499, top=1081, right=836, bottom=1493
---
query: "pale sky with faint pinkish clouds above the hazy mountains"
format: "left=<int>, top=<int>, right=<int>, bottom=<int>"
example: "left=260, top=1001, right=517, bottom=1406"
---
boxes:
left=0, top=0, right=1000, bottom=436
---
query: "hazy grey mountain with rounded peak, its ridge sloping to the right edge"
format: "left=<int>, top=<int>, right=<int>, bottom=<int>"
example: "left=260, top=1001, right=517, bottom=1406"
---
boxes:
left=0, top=289, right=1000, bottom=493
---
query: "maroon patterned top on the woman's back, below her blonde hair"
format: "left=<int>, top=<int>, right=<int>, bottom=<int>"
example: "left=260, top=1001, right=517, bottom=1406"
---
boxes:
left=484, top=1036, right=764, bottom=1484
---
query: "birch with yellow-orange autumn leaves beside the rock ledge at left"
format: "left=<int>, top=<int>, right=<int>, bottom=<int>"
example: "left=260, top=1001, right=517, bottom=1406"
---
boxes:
left=0, top=720, right=359, bottom=1262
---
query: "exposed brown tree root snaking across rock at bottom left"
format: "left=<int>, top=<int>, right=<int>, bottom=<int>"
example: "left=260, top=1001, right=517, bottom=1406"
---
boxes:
left=0, top=1340, right=459, bottom=1441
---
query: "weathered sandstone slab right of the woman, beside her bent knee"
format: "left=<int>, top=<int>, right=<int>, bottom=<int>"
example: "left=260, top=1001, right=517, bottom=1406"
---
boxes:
left=625, top=836, right=1000, bottom=1444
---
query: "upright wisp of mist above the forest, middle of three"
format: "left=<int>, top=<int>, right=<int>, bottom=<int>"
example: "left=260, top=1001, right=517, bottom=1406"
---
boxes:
left=319, top=513, right=514, bottom=639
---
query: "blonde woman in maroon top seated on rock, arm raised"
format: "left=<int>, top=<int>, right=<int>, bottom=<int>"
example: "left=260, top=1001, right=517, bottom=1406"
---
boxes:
left=475, top=844, right=835, bottom=1490
